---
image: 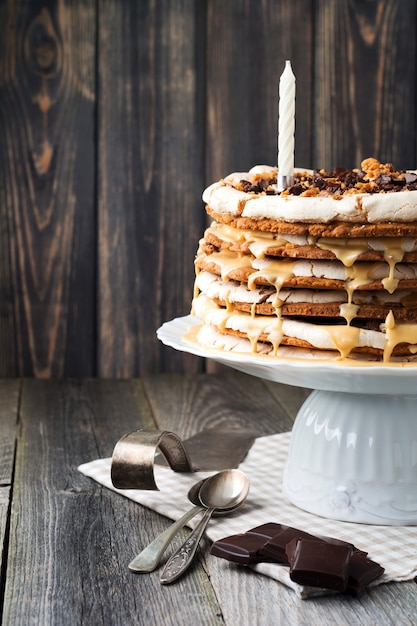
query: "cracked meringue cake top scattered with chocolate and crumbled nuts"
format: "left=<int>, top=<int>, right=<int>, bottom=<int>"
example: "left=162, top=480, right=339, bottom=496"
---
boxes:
left=203, top=158, right=417, bottom=224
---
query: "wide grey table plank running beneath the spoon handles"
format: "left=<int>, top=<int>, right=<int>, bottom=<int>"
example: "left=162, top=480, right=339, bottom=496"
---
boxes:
left=3, top=381, right=221, bottom=626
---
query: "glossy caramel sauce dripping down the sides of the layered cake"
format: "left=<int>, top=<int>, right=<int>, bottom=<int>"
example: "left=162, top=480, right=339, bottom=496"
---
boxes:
left=194, top=223, right=417, bottom=361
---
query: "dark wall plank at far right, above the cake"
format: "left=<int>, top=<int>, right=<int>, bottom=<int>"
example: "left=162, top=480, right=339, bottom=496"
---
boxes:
left=313, top=0, right=416, bottom=169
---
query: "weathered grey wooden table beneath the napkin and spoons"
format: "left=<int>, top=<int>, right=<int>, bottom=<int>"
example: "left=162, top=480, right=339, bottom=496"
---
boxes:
left=0, top=372, right=417, bottom=626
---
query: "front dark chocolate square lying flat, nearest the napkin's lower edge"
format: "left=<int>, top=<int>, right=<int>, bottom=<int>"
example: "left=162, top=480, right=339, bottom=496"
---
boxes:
left=290, top=539, right=352, bottom=591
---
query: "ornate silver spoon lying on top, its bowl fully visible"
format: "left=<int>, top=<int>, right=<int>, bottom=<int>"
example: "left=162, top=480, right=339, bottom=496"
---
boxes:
left=159, top=469, right=249, bottom=585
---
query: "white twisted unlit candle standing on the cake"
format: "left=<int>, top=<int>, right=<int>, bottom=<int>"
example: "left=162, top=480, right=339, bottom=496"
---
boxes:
left=277, top=61, right=295, bottom=191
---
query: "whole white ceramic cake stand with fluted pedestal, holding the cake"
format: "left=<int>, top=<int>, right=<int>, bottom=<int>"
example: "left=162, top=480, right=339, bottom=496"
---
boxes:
left=157, top=316, right=417, bottom=526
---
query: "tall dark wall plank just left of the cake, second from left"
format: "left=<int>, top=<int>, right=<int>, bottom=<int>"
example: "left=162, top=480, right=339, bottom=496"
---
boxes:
left=98, top=0, right=204, bottom=377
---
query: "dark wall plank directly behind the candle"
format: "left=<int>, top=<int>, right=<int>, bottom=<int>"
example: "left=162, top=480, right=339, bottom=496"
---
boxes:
left=206, top=0, right=313, bottom=182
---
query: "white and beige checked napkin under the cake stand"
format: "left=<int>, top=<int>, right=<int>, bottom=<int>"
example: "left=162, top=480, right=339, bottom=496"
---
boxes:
left=78, top=433, right=417, bottom=598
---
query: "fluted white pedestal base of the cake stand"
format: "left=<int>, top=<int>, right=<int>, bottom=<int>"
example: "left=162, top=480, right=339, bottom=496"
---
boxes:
left=283, top=390, right=417, bottom=525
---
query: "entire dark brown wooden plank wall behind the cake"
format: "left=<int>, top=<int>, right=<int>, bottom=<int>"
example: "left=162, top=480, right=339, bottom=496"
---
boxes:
left=0, top=0, right=417, bottom=377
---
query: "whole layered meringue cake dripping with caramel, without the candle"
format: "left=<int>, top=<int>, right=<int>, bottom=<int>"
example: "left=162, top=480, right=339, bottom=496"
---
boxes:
left=192, top=158, right=417, bottom=362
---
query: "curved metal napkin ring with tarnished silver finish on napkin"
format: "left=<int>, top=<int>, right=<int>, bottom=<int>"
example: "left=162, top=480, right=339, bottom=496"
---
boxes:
left=111, top=430, right=193, bottom=490
